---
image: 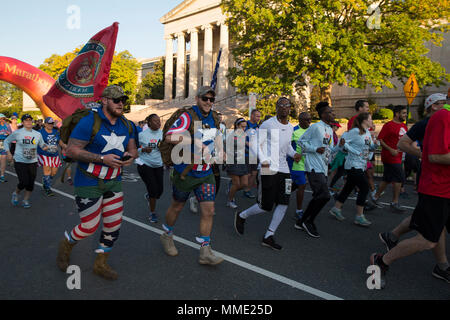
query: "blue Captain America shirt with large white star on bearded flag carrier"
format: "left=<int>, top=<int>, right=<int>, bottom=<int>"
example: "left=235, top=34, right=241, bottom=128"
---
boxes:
left=70, top=108, right=134, bottom=187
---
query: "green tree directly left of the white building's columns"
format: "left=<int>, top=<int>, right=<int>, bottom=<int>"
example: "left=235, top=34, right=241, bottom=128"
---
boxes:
left=136, top=59, right=164, bottom=104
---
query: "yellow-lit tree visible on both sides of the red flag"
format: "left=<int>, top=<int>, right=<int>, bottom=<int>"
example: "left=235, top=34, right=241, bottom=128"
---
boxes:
left=39, top=46, right=140, bottom=110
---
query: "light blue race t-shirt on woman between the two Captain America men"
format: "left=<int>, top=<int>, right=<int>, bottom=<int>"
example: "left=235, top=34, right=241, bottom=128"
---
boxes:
left=136, top=129, right=163, bottom=168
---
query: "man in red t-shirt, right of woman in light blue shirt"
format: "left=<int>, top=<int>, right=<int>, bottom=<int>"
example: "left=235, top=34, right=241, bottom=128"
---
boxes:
left=372, top=106, right=408, bottom=213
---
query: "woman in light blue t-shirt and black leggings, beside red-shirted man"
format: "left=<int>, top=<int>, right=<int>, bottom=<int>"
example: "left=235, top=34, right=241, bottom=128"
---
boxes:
left=330, top=113, right=378, bottom=227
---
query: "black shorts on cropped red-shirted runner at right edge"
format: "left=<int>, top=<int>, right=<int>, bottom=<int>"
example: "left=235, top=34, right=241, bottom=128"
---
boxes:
left=409, top=193, right=450, bottom=243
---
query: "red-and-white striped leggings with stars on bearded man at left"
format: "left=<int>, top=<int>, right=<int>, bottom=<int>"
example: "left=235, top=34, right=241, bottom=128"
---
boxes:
left=70, top=191, right=123, bottom=249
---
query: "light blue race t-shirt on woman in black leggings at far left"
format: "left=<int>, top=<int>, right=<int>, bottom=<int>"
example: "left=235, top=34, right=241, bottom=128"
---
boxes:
left=4, top=128, right=45, bottom=163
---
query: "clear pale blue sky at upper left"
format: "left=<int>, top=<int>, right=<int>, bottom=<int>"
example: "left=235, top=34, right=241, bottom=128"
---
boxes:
left=0, top=0, right=182, bottom=67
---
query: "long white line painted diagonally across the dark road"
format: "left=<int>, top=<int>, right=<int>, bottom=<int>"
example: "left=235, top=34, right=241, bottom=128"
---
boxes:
left=5, top=171, right=344, bottom=300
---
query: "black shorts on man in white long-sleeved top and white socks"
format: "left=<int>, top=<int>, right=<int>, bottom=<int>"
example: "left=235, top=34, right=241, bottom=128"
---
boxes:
left=257, top=172, right=292, bottom=211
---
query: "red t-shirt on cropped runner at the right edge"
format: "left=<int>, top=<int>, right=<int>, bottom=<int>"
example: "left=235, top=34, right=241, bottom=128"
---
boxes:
left=419, top=109, right=450, bottom=199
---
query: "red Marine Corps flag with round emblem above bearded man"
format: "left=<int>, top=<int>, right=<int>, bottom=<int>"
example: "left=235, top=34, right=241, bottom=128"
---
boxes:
left=44, top=22, right=119, bottom=119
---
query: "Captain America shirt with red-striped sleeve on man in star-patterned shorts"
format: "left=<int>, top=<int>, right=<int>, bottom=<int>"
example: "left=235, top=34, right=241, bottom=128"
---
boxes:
left=167, top=106, right=220, bottom=178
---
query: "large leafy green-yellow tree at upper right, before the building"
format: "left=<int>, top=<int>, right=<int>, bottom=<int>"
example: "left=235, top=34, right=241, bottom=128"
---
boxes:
left=222, top=0, right=450, bottom=100
